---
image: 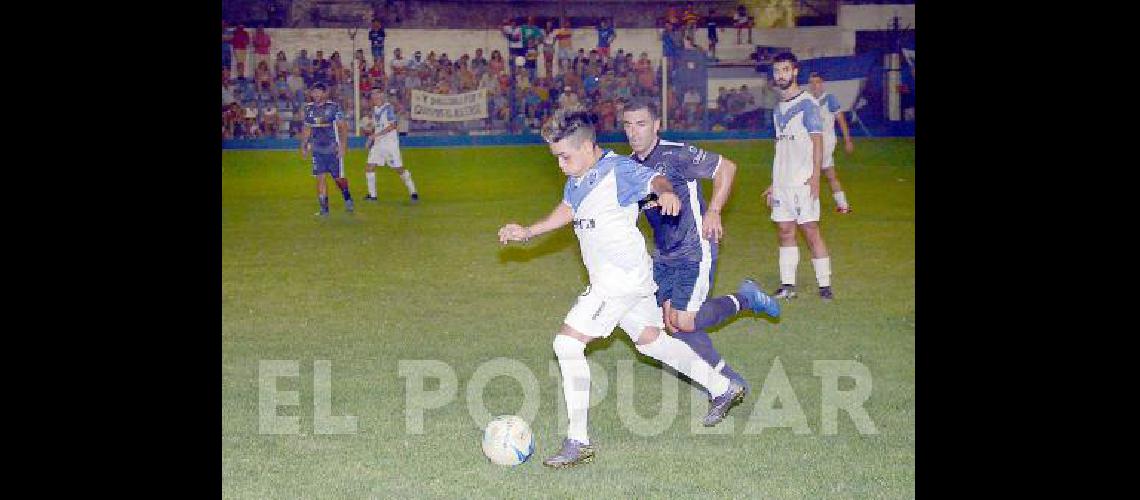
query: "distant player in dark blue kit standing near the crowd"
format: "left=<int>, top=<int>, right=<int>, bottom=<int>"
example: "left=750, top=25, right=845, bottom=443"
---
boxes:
left=301, top=81, right=352, bottom=216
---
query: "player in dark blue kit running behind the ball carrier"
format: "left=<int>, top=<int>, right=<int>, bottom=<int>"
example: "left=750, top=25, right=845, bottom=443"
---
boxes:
left=621, top=99, right=780, bottom=396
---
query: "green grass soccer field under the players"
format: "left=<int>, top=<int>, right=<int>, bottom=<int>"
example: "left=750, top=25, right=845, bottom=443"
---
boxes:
left=221, top=139, right=914, bottom=499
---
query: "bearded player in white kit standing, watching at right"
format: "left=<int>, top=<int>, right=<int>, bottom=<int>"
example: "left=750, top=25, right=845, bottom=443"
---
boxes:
left=764, top=52, right=832, bottom=301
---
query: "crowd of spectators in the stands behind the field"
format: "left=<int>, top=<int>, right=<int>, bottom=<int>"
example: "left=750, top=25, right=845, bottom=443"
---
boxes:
left=221, top=3, right=776, bottom=139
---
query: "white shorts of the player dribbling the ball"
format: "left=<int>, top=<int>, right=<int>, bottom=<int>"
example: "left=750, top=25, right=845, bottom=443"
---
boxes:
left=562, top=288, right=665, bottom=342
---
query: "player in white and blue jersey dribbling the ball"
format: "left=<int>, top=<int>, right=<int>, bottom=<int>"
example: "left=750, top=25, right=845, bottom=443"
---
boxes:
left=498, top=106, right=746, bottom=467
